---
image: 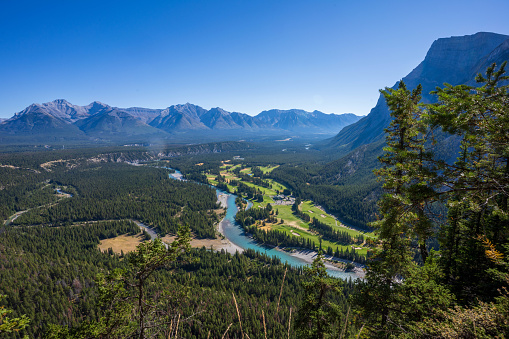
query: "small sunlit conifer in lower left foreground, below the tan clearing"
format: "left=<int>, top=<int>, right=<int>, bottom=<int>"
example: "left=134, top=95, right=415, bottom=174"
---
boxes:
left=47, top=227, right=190, bottom=339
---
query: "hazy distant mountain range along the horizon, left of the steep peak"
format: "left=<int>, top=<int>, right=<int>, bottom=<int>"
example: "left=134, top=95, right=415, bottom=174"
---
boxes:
left=0, top=99, right=361, bottom=142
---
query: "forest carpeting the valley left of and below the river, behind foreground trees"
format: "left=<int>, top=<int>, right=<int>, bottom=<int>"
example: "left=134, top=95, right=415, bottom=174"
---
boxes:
left=0, top=147, right=355, bottom=338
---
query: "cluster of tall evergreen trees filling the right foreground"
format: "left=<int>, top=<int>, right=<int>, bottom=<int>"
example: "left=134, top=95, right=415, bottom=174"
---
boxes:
left=356, top=63, right=509, bottom=337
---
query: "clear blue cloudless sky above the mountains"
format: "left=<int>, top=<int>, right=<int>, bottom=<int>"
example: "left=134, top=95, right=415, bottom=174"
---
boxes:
left=0, top=0, right=509, bottom=118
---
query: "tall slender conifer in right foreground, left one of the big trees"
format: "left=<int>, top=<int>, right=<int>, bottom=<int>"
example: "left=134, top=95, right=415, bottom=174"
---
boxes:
left=357, top=81, right=448, bottom=335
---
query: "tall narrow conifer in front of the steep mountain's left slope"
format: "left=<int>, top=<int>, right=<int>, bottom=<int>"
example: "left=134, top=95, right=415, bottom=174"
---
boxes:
left=359, top=82, right=425, bottom=331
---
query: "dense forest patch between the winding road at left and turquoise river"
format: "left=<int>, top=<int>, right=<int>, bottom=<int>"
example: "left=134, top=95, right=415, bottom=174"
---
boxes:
left=13, top=163, right=217, bottom=238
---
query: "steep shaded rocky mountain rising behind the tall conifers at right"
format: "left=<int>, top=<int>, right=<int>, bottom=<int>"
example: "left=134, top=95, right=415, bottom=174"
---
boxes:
left=329, top=32, right=509, bottom=152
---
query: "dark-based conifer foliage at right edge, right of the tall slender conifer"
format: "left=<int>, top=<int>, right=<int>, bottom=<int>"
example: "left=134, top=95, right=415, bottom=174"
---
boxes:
left=429, top=63, right=509, bottom=303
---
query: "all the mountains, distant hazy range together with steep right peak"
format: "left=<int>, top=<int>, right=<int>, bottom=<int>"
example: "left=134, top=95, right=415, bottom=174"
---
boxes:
left=0, top=32, right=509, bottom=149
